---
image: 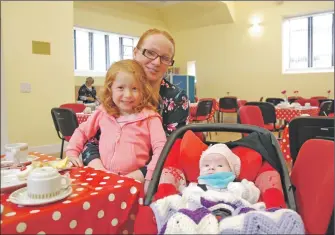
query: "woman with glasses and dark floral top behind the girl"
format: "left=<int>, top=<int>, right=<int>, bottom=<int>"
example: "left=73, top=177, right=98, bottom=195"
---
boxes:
left=75, top=29, right=189, bottom=176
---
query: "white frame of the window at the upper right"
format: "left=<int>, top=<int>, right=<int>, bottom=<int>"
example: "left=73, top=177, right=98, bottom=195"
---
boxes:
left=282, top=11, right=335, bottom=74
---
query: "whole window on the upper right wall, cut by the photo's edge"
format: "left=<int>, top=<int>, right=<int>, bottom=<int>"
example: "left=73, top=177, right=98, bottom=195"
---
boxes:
left=283, top=12, right=334, bottom=73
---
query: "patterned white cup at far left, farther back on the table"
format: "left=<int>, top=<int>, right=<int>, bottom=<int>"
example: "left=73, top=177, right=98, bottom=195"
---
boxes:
left=5, top=143, right=28, bottom=164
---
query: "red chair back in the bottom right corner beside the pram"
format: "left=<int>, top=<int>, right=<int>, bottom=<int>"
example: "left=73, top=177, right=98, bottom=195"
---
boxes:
left=291, top=139, right=334, bottom=234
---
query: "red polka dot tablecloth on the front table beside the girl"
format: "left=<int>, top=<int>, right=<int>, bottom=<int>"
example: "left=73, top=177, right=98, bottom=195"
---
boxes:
left=1, top=152, right=143, bottom=234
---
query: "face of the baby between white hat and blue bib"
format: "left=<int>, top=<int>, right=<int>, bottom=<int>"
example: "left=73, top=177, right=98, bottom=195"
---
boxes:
left=200, top=153, right=232, bottom=175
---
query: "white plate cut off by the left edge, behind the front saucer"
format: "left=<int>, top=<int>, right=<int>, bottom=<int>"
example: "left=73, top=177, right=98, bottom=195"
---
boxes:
left=1, top=173, right=27, bottom=192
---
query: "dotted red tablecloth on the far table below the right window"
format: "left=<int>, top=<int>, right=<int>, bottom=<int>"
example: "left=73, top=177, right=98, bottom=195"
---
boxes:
left=276, top=107, right=319, bottom=122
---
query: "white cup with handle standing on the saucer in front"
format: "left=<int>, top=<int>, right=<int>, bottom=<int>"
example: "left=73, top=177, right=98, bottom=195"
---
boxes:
left=27, top=167, right=71, bottom=199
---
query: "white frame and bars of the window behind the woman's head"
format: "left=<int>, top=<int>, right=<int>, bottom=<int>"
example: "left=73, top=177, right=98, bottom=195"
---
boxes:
left=73, top=26, right=139, bottom=76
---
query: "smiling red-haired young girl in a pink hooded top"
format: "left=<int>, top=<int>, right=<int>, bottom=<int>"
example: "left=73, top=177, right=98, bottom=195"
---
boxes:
left=66, top=60, right=166, bottom=186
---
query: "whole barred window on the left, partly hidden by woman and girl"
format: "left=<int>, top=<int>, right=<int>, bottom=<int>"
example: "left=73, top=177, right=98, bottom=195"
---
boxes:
left=73, top=28, right=139, bottom=76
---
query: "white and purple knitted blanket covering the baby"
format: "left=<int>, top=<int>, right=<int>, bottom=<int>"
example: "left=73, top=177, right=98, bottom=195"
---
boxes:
left=150, top=187, right=305, bottom=234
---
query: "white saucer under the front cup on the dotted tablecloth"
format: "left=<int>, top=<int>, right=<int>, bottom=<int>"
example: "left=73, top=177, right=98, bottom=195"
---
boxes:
left=8, top=186, right=72, bottom=206
